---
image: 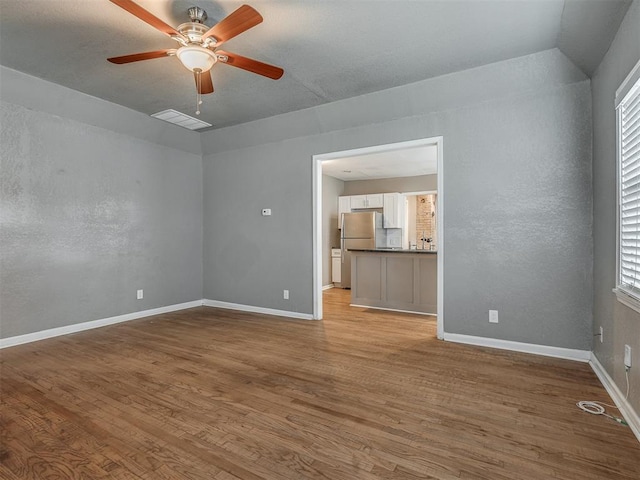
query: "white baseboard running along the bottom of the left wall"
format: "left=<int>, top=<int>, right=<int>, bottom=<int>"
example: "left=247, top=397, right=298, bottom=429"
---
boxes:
left=0, top=300, right=202, bottom=349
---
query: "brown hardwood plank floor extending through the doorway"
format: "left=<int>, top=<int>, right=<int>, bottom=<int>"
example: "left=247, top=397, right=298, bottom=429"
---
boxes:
left=0, top=289, right=640, bottom=480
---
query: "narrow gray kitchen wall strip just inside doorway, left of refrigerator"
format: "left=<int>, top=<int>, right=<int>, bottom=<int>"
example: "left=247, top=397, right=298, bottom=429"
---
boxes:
left=322, top=175, right=344, bottom=286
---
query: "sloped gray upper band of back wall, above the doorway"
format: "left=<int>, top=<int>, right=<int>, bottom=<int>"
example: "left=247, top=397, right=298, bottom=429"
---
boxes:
left=201, top=49, right=587, bottom=155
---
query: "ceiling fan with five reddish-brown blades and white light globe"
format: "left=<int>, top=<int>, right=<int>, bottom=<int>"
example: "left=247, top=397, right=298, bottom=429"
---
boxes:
left=107, top=0, right=284, bottom=114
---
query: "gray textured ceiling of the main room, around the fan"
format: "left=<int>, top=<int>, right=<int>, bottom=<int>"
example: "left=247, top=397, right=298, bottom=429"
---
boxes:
left=0, top=0, right=630, bottom=128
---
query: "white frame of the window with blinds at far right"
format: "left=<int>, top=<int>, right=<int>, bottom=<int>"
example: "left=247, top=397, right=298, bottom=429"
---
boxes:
left=613, top=62, right=640, bottom=312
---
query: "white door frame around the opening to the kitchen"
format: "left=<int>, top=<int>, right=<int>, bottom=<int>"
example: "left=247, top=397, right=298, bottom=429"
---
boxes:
left=311, top=136, right=445, bottom=339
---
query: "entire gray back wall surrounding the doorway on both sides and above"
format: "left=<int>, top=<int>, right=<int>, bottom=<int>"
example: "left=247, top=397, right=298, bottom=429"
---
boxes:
left=202, top=49, right=592, bottom=349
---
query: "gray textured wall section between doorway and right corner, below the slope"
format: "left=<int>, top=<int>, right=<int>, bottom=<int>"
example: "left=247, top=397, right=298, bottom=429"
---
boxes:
left=440, top=85, right=592, bottom=350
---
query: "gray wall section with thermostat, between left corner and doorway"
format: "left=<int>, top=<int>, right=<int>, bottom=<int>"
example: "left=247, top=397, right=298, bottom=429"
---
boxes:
left=203, top=144, right=313, bottom=313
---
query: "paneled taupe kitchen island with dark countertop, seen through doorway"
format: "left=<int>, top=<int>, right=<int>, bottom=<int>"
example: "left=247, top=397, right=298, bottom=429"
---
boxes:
left=349, top=248, right=438, bottom=315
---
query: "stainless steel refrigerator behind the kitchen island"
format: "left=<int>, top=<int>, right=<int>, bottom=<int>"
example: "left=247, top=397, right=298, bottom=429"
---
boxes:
left=337, top=212, right=384, bottom=288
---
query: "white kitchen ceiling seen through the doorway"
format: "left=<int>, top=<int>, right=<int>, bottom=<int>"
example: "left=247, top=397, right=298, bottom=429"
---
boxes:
left=322, top=145, right=438, bottom=181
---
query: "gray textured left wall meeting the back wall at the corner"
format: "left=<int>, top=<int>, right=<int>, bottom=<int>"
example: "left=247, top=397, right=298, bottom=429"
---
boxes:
left=0, top=70, right=202, bottom=337
